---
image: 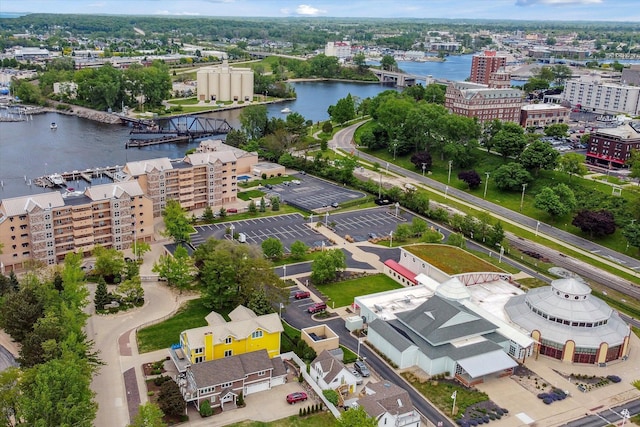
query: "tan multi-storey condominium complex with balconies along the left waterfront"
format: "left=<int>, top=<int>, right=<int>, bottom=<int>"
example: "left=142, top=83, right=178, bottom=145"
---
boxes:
left=0, top=140, right=258, bottom=270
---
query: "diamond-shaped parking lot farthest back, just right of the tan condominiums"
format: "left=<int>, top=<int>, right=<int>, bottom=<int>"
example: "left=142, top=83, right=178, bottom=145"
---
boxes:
left=267, top=174, right=366, bottom=211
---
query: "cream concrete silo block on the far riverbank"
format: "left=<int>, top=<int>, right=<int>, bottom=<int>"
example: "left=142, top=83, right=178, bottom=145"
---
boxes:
left=196, top=61, right=253, bottom=102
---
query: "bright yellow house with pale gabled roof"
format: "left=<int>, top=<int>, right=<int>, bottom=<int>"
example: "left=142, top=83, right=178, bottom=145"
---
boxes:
left=169, top=305, right=284, bottom=372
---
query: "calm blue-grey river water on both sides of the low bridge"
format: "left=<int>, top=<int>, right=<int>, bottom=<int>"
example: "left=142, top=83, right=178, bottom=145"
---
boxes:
left=0, top=82, right=398, bottom=199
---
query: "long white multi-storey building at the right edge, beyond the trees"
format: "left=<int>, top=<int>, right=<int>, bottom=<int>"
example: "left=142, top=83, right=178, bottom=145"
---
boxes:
left=562, top=76, right=640, bottom=116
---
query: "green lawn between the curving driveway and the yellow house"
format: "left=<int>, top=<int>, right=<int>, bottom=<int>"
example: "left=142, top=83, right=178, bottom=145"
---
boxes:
left=138, top=299, right=215, bottom=353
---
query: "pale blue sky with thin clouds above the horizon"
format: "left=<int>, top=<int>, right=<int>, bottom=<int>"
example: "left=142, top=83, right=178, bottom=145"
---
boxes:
left=0, top=0, right=640, bottom=24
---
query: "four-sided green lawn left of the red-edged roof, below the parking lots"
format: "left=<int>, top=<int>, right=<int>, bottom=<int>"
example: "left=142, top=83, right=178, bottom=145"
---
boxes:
left=318, top=274, right=402, bottom=307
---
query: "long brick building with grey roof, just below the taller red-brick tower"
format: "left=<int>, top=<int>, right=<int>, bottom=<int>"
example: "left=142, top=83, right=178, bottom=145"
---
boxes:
left=444, top=82, right=524, bottom=123
